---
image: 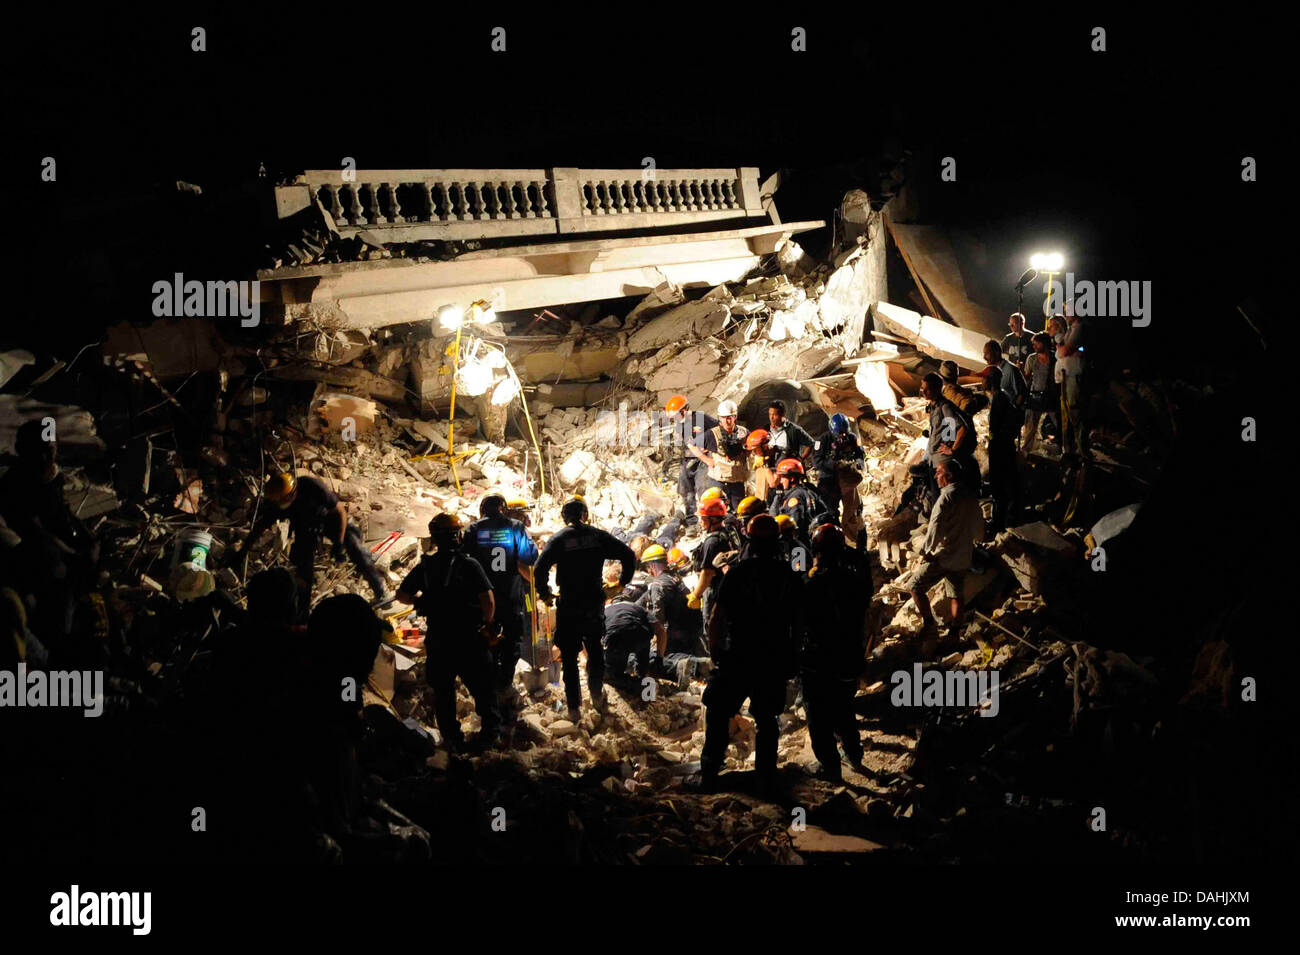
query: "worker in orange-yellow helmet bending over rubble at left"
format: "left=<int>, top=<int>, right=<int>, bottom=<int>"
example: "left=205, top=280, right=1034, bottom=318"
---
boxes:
left=241, top=472, right=393, bottom=608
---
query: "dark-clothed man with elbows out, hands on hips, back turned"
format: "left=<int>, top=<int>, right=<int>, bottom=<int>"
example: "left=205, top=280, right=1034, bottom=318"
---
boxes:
left=533, top=498, right=637, bottom=720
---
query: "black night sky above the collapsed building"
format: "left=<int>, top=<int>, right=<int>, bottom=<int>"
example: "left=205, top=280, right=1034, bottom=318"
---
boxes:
left=10, top=6, right=1282, bottom=361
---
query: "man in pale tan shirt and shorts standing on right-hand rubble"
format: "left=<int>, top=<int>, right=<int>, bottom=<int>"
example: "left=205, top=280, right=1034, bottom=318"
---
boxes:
left=907, top=460, right=984, bottom=629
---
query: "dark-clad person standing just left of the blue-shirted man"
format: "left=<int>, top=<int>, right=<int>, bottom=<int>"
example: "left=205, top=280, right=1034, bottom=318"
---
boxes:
left=398, top=513, right=502, bottom=750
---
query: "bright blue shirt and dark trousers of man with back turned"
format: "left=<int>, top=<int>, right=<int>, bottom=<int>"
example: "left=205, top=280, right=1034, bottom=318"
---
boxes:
left=465, top=516, right=537, bottom=690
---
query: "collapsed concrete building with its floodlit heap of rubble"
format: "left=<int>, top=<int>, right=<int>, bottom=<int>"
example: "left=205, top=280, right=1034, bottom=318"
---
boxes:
left=0, top=168, right=1268, bottom=863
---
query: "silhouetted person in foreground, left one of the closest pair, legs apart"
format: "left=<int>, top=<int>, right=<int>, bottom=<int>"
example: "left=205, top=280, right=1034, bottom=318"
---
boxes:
left=698, top=515, right=798, bottom=791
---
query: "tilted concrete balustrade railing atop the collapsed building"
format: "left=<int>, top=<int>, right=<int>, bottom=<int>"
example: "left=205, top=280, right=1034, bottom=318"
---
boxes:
left=276, top=166, right=766, bottom=242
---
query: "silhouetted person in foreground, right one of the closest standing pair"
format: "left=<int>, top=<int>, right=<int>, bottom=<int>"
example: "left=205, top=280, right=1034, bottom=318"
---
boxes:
left=796, top=524, right=872, bottom=782
